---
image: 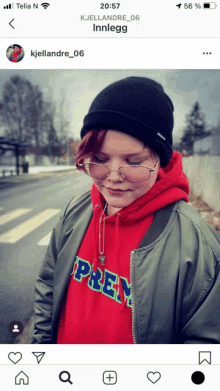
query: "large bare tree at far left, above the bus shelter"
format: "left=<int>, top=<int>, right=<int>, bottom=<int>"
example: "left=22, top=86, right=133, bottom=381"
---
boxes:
left=0, top=75, right=69, bottom=162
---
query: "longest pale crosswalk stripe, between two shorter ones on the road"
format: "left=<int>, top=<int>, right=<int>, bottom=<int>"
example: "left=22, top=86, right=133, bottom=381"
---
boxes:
left=0, top=209, right=60, bottom=243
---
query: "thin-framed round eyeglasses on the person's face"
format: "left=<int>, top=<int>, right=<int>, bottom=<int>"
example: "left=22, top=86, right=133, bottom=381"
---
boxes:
left=79, top=162, right=158, bottom=182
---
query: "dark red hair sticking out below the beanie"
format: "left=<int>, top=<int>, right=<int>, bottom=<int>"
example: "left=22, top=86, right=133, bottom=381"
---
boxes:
left=76, top=130, right=108, bottom=171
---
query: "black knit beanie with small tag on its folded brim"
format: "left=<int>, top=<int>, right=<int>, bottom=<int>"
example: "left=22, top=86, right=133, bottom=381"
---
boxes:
left=81, top=77, right=174, bottom=167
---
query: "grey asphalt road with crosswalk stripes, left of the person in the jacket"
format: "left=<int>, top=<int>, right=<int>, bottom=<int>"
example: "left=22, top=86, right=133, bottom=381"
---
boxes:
left=0, top=171, right=92, bottom=344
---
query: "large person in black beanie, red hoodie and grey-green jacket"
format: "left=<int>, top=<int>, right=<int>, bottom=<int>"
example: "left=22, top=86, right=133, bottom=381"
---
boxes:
left=32, top=77, right=220, bottom=344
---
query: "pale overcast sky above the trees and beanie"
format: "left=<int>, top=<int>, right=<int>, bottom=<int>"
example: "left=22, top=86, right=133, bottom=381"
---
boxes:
left=0, top=69, right=220, bottom=140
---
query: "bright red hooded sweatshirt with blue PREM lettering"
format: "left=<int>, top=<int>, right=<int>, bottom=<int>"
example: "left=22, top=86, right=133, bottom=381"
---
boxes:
left=57, top=152, right=189, bottom=344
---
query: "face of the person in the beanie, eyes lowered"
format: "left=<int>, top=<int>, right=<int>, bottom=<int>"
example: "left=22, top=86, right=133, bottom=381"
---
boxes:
left=89, top=130, right=159, bottom=215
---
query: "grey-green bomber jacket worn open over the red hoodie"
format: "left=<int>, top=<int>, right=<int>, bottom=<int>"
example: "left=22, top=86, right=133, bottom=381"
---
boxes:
left=32, top=191, right=220, bottom=344
